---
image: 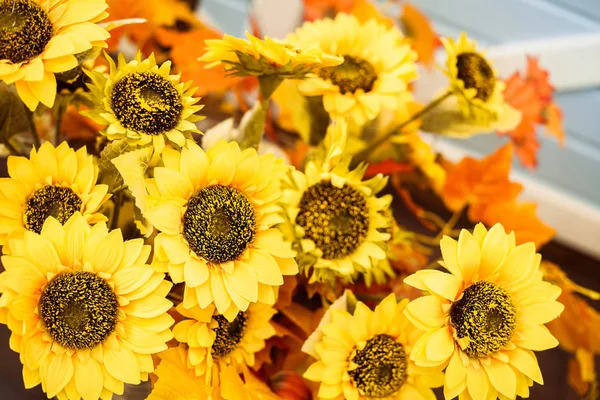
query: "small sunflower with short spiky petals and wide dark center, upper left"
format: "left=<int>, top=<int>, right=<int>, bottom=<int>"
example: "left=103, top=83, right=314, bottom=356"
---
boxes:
left=82, top=53, right=203, bottom=154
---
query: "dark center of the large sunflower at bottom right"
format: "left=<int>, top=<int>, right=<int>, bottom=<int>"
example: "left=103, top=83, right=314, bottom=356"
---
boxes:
left=450, top=281, right=517, bottom=358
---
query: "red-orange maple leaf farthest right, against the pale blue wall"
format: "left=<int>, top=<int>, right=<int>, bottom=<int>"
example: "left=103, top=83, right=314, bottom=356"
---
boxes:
left=499, top=57, right=565, bottom=169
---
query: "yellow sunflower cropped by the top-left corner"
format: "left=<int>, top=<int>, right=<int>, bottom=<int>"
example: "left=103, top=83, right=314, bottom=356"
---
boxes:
left=0, top=0, right=110, bottom=111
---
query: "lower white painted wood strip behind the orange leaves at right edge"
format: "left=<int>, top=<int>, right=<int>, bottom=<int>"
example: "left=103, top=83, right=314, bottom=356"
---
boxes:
left=433, top=140, right=600, bottom=257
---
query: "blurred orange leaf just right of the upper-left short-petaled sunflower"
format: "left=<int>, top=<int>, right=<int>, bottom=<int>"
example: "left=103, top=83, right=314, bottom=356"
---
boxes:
left=156, top=26, right=239, bottom=96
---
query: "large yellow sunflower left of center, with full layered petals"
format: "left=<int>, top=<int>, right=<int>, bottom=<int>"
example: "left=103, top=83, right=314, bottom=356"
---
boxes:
left=145, top=140, right=298, bottom=320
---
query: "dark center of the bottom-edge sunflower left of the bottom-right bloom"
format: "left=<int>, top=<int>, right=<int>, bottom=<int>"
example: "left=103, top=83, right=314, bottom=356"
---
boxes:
left=348, top=335, right=407, bottom=398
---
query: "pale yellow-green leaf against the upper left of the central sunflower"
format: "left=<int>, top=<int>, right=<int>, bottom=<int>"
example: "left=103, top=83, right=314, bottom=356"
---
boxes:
left=111, top=146, right=154, bottom=212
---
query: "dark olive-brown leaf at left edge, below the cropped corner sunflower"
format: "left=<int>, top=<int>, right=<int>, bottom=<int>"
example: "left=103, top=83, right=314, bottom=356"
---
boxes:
left=0, top=83, right=29, bottom=150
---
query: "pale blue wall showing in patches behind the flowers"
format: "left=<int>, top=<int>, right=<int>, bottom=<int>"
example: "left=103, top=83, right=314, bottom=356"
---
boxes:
left=203, top=0, right=600, bottom=208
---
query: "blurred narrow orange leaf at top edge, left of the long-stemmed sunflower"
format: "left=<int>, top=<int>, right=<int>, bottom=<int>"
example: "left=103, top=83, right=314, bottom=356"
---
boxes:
left=400, top=3, right=441, bottom=66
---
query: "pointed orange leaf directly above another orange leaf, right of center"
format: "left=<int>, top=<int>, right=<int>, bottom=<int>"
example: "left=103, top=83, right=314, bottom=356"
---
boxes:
left=442, top=144, right=522, bottom=221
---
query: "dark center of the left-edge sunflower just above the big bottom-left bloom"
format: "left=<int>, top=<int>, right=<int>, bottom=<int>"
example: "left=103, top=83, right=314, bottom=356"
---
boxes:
left=25, top=185, right=83, bottom=233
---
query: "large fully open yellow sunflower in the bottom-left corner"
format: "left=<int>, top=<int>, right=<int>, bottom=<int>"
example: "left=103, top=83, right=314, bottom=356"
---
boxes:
left=0, top=213, right=173, bottom=400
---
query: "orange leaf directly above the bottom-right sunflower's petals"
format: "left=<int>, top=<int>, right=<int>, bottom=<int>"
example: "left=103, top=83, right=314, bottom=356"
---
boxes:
left=479, top=200, right=556, bottom=248
